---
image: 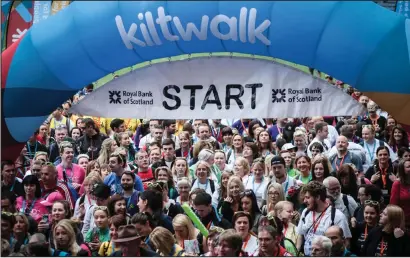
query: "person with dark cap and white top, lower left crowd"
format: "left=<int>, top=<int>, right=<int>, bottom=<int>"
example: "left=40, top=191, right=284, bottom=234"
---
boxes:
left=81, top=183, right=111, bottom=238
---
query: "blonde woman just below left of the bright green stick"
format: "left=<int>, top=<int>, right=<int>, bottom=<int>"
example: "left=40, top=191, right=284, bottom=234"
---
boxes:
left=172, top=214, right=204, bottom=255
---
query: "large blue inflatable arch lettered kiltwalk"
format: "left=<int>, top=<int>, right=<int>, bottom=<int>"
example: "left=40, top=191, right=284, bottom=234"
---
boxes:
left=2, top=1, right=410, bottom=158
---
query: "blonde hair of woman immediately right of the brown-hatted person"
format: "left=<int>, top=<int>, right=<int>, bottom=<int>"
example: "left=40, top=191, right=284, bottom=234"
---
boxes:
left=149, top=227, right=175, bottom=256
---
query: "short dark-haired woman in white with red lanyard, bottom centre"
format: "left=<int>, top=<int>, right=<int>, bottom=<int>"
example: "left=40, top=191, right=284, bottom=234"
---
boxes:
left=232, top=211, right=258, bottom=256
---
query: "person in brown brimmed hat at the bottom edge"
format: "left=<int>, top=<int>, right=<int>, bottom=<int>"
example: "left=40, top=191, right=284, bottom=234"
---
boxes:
left=111, top=225, right=159, bottom=257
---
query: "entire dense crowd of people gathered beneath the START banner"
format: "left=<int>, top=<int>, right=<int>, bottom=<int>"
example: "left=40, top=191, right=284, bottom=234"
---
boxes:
left=1, top=79, right=410, bottom=257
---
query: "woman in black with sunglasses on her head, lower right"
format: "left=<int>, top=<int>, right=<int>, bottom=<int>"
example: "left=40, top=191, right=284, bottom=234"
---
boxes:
left=350, top=200, right=380, bottom=255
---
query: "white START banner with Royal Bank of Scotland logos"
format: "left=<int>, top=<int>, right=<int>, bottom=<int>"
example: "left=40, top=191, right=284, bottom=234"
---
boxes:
left=71, top=57, right=365, bottom=119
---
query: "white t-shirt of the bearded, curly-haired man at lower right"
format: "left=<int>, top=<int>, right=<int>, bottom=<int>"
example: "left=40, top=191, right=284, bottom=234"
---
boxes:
left=296, top=206, right=352, bottom=256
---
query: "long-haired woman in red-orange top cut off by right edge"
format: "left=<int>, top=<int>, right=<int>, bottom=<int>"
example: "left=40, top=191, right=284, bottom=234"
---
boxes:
left=390, top=159, right=410, bottom=230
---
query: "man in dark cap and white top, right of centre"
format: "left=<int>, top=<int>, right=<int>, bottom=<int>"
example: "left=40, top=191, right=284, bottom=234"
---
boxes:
left=265, top=156, right=302, bottom=200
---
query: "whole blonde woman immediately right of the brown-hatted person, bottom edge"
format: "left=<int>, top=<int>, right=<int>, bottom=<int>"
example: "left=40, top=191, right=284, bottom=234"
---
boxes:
left=149, top=227, right=185, bottom=257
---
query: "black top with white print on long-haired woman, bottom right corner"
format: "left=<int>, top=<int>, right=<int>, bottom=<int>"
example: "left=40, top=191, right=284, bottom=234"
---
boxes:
left=361, top=226, right=410, bottom=256
